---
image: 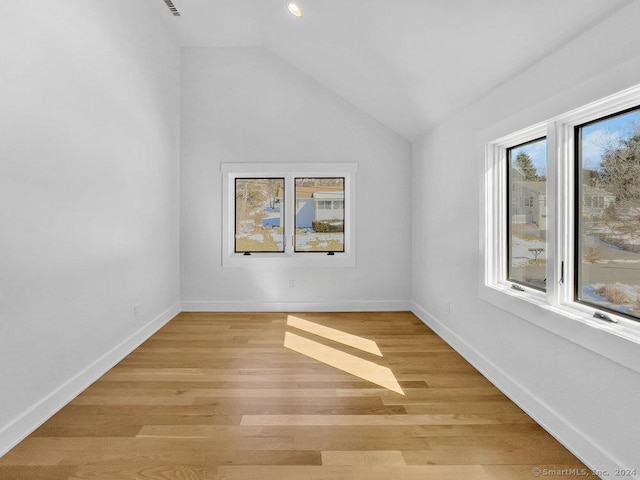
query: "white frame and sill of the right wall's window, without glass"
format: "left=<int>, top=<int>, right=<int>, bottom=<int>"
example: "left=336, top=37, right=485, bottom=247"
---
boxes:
left=480, top=85, right=640, bottom=373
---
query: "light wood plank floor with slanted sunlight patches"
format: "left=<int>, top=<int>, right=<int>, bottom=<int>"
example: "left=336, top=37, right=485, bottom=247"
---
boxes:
left=0, top=312, right=586, bottom=480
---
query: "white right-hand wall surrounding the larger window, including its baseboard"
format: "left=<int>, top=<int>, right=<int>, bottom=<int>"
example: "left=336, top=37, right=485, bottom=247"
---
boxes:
left=412, top=2, right=640, bottom=472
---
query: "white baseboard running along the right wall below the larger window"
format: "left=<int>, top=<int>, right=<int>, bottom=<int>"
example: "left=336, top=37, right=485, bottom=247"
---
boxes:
left=411, top=302, right=630, bottom=472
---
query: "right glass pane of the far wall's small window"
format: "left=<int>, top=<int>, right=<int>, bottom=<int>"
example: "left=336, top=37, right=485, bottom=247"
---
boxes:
left=294, top=177, right=344, bottom=252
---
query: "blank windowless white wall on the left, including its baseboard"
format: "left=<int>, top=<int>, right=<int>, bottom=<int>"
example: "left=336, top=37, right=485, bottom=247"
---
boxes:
left=0, top=0, right=179, bottom=455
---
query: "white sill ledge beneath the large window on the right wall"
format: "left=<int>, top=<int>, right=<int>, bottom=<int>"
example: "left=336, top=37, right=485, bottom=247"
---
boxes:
left=480, top=285, right=640, bottom=373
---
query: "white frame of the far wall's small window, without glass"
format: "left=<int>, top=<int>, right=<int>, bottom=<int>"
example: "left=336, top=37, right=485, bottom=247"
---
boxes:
left=220, top=163, right=358, bottom=268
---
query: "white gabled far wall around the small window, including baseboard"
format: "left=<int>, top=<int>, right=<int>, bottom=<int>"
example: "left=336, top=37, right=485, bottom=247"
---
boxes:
left=181, top=47, right=411, bottom=310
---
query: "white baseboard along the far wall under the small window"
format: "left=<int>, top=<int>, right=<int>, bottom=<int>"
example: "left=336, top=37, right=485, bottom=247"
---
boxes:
left=182, top=300, right=411, bottom=312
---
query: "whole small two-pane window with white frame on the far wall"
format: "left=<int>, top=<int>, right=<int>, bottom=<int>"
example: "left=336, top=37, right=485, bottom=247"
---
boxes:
left=221, top=163, right=357, bottom=267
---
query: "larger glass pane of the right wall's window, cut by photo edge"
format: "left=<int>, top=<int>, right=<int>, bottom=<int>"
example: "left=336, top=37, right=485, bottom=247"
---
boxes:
left=576, top=109, right=640, bottom=318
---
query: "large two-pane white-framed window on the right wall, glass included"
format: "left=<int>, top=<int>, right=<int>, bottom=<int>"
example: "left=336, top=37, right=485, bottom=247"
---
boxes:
left=481, top=86, right=640, bottom=364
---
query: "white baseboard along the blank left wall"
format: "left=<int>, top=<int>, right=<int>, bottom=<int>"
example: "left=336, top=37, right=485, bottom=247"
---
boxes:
left=0, top=304, right=180, bottom=457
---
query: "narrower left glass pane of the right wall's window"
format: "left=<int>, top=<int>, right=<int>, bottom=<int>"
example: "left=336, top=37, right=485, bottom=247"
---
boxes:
left=507, top=138, right=547, bottom=291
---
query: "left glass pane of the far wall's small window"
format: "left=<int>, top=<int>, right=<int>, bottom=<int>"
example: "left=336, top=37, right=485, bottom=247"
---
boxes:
left=235, top=178, right=284, bottom=252
